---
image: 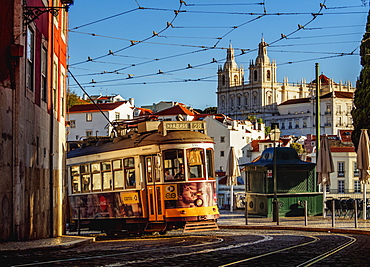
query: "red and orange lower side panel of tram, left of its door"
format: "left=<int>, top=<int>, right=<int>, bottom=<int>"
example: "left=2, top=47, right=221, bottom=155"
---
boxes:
left=70, top=192, right=143, bottom=219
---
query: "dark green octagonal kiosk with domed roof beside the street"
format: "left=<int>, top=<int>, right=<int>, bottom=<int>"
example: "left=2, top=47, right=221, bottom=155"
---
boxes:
left=243, top=147, right=323, bottom=217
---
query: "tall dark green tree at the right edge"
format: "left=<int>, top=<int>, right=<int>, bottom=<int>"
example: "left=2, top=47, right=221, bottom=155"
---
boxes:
left=351, top=11, right=370, bottom=150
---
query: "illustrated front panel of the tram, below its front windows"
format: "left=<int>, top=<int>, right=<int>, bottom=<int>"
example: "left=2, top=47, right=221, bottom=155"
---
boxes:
left=164, top=182, right=216, bottom=208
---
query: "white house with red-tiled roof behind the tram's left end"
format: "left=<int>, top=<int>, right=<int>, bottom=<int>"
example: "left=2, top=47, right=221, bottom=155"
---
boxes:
left=67, top=101, right=134, bottom=141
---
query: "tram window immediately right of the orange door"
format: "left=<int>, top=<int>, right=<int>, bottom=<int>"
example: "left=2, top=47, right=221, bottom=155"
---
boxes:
left=163, top=149, right=185, bottom=181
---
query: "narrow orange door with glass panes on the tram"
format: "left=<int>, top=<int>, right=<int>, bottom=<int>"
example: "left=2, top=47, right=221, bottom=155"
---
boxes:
left=145, top=155, right=164, bottom=221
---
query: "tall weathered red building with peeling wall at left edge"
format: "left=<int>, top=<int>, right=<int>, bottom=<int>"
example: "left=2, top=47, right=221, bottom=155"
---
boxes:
left=0, top=0, right=73, bottom=240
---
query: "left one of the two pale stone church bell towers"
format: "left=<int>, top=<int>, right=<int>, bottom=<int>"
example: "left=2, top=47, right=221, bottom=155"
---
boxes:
left=217, top=44, right=244, bottom=91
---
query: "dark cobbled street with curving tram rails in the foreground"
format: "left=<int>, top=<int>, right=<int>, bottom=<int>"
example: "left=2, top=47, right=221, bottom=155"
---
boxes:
left=8, top=231, right=363, bottom=267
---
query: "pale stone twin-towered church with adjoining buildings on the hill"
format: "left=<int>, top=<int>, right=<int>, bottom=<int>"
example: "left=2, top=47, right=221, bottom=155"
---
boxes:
left=217, top=38, right=356, bottom=136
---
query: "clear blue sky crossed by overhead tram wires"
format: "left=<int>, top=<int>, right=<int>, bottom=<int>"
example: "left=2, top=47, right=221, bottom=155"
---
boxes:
left=68, top=0, right=369, bottom=109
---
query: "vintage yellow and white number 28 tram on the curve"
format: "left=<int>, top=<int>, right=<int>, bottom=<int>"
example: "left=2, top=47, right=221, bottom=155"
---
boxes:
left=67, top=121, right=219, bottom=234
